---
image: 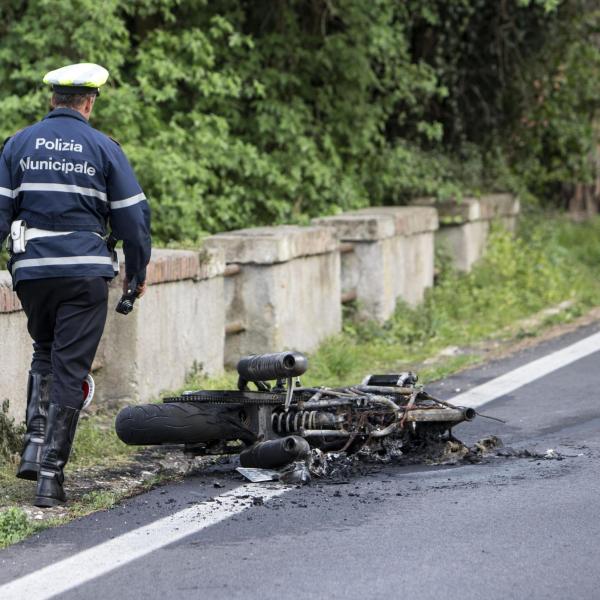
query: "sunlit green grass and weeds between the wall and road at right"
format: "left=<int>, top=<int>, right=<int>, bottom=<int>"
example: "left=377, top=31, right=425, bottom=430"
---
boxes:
left=310, top=214, right=600, bottom=385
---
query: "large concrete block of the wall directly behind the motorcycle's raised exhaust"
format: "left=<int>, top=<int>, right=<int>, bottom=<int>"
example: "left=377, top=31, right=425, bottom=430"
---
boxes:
left=205, top=225, right=341, bottom=365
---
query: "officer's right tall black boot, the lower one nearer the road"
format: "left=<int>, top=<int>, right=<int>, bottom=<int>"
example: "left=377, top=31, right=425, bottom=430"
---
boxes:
left=34, top=404, right=79, bottom=507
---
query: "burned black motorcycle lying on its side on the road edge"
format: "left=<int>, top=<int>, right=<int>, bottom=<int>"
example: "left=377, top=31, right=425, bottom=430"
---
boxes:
left=116, top=352, right=476, bottom=469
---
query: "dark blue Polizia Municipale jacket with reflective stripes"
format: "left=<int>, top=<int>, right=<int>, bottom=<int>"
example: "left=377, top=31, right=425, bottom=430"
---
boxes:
left=0, top=108, right=150, bottom=286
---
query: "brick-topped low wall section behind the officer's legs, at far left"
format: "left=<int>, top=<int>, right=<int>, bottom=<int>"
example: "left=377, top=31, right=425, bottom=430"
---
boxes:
left=0, top=250, right=225, bottom=418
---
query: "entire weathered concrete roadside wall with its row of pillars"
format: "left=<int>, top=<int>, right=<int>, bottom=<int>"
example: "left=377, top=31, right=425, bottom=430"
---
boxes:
left=0, top=194, right=519, bottom=418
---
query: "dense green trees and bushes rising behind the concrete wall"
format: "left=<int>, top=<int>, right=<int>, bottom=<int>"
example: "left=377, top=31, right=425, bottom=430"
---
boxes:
left=0, top=0, right=600, bottom=242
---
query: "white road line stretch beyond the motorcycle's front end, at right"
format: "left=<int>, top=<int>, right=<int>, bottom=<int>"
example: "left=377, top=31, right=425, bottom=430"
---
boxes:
left=451, top=333, right=600, bottom=408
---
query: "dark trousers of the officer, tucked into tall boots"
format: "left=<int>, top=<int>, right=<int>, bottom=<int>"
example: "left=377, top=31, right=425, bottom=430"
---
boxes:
left=17, top=277, right=108, bottom=409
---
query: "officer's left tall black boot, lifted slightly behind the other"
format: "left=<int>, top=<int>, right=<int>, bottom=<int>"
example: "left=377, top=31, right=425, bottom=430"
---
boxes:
left=17, top=371, right=52, bottom=481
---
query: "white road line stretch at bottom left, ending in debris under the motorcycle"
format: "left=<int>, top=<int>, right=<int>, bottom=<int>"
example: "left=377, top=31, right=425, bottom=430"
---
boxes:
left=0, top=483, right=290, bottom=600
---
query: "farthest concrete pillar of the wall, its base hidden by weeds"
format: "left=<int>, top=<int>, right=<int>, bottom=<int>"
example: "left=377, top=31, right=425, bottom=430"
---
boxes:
left=415, top=194, right=520, bottom=271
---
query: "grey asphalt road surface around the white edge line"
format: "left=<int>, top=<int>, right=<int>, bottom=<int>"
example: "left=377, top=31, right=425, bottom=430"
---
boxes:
left=0, top=325, right=600, bottom=600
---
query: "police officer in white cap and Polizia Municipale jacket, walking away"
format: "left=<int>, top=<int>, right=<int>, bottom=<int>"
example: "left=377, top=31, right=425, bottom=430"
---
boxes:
left=0, top=63, right=150, bottom=507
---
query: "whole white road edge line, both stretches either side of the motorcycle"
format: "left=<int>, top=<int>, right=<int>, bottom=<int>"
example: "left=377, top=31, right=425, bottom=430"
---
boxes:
left=0, top=333, right=600, bottom=600
